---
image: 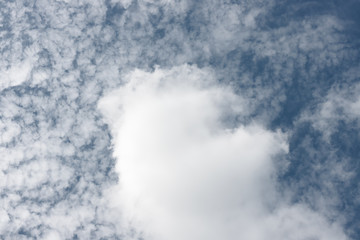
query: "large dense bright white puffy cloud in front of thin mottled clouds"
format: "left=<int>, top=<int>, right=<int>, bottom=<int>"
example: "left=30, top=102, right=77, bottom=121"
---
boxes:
left=99, top=65, right=346, bottom=240
